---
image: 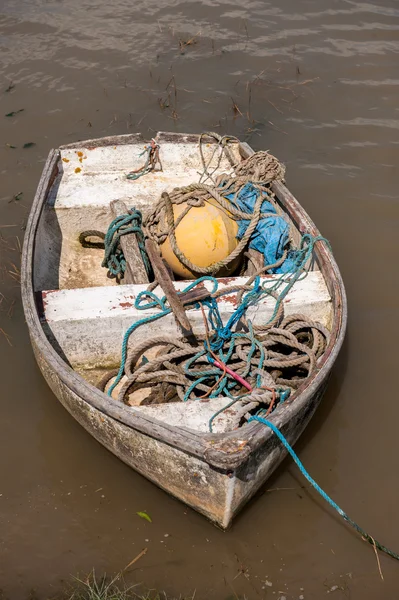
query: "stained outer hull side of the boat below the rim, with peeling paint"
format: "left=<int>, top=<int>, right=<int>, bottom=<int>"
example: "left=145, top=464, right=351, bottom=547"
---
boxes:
left=32, top=336, right=325, bottom=529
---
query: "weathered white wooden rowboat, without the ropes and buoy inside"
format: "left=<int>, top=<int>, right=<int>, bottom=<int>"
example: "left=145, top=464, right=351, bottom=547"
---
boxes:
left=22, top=133, right=347, bottom=528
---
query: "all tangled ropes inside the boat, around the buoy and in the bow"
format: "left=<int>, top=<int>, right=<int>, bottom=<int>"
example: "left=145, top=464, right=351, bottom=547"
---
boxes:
left=81, top=134, right=329, bottom=430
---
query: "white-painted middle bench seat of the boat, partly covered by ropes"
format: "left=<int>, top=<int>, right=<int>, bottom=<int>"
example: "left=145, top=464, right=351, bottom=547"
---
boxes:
left=41, top=271, right=333, bottom=370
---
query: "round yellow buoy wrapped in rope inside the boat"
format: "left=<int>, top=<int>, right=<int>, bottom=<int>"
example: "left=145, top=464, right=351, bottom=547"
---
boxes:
left=161, top=202, right=239, bottom=279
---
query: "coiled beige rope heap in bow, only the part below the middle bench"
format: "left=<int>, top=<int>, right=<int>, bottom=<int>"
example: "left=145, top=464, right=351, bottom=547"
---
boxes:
left=108, top=315, right=328, bottom=412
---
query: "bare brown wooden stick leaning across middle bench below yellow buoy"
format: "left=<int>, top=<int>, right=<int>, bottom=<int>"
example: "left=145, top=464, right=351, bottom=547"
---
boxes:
left=145, top=239, right=193, bottom=336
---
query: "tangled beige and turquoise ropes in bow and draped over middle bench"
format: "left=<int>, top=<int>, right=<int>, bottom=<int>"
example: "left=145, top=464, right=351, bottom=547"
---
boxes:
left=99, top=234, right=329, bottom=431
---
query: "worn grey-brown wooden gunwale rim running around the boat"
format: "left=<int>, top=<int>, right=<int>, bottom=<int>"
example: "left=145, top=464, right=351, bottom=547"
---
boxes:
left=21, top=132, right=347, bottom=472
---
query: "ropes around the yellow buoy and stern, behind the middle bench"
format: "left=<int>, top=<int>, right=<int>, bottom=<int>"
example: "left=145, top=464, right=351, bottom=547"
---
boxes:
left=79, top=133, right=285, bottom=281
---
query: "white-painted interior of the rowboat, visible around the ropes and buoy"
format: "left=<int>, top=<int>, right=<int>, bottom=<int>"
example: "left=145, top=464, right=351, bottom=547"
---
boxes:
left=34, top=133, right=333, bottom=432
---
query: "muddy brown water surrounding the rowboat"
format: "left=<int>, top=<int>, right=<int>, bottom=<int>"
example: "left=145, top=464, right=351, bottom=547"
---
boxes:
left=0, top=0, right=399, bottom=600
